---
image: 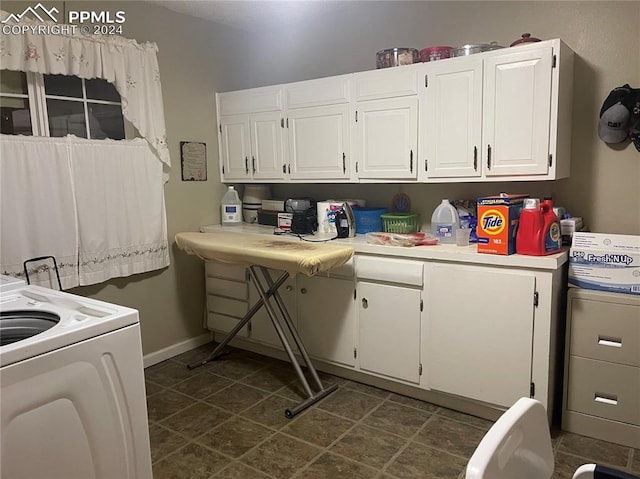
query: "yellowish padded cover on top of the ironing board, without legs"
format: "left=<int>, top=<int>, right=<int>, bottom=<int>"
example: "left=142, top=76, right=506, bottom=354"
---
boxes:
left=176, top=232, right=354, bottom=276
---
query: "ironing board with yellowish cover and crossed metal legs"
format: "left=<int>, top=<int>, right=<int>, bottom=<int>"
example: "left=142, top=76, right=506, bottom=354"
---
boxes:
left=175, top=232, right=354, bottom=419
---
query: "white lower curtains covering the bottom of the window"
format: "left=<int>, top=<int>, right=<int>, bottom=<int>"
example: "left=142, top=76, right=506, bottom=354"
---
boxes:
left=0, top=135, right=169, bottom=289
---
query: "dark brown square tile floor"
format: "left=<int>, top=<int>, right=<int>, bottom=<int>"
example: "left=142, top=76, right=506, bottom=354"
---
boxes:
left=145, top=346, right=640, bottom=479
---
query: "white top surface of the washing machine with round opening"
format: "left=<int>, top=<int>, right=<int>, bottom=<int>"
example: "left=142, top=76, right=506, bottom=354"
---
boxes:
left=0, top=286, right=139, bottom=367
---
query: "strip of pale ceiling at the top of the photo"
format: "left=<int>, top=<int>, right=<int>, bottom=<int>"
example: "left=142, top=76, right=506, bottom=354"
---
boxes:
left=149, top=0, right=349, bottom=30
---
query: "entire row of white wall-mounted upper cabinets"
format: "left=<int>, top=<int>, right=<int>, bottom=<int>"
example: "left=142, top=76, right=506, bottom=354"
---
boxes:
left=217, top=39, right=573, bottom=183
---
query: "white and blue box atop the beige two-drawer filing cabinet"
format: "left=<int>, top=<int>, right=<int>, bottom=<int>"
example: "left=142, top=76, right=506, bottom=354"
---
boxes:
left=569, top=231, right=640, bottom=294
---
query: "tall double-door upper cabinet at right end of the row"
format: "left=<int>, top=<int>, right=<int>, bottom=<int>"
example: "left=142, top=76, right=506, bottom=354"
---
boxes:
left=420, top=40, right=573, bottom=182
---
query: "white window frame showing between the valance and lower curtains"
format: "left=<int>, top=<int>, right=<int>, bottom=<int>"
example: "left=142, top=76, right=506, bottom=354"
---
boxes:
left=0, top=72, right=130, bottom=141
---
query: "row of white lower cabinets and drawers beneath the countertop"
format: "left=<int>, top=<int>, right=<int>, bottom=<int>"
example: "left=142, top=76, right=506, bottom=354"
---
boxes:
left=205, top=244, right=564, bottom=421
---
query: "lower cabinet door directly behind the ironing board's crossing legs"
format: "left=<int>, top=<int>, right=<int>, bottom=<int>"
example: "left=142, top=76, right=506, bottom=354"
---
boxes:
left=249, top=270, right=297, bottom=349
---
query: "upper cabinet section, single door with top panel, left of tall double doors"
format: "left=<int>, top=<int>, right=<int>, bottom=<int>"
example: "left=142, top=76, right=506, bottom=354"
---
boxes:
left=352, top=66, right=418, bottom=180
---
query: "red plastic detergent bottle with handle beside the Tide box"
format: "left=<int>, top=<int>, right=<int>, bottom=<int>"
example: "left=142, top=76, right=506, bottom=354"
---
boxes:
left=516, top=198, right=561, bottom=256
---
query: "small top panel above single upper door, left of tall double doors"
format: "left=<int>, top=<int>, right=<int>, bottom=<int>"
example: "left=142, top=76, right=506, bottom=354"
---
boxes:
left=354, top=68, right=418, bottom=101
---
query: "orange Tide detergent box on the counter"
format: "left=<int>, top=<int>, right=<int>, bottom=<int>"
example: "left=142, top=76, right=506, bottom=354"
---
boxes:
left=477, top=193, right=529, bottom=255
